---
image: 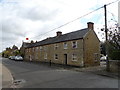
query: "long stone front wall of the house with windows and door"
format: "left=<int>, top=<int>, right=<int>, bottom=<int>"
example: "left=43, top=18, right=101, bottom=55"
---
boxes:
left=25, top=39, right=83, bottom=66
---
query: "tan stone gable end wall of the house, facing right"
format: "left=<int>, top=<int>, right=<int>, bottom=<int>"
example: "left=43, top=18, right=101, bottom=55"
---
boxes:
left=84, top=30, right=100, bottom=66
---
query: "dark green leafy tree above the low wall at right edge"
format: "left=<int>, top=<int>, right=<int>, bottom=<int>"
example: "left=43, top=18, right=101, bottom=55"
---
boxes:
left=108, top=28, right=120, bottom=60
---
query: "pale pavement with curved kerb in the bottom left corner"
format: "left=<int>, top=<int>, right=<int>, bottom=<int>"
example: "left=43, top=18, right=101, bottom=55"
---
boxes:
left=0, top=63, right=13, bottom=88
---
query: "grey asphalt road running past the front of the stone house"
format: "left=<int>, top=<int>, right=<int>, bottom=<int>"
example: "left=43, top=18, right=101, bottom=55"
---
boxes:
left=2, top=58, right=118, bottom=88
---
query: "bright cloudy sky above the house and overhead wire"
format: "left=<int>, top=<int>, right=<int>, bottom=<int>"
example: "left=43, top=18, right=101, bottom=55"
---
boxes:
left=0, top=0, right=118, bottom=52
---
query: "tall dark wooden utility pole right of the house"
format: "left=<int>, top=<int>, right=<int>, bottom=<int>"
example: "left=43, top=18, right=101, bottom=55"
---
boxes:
left=104, top=5, right=110, bottom=71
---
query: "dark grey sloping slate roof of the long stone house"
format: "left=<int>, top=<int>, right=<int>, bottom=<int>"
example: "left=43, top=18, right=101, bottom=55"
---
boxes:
left=27, top=28, right=88, bottom=48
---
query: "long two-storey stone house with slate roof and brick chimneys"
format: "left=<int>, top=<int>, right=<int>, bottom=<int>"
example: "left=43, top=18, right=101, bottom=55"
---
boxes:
left=24, top=22, right=100, bottom=67
